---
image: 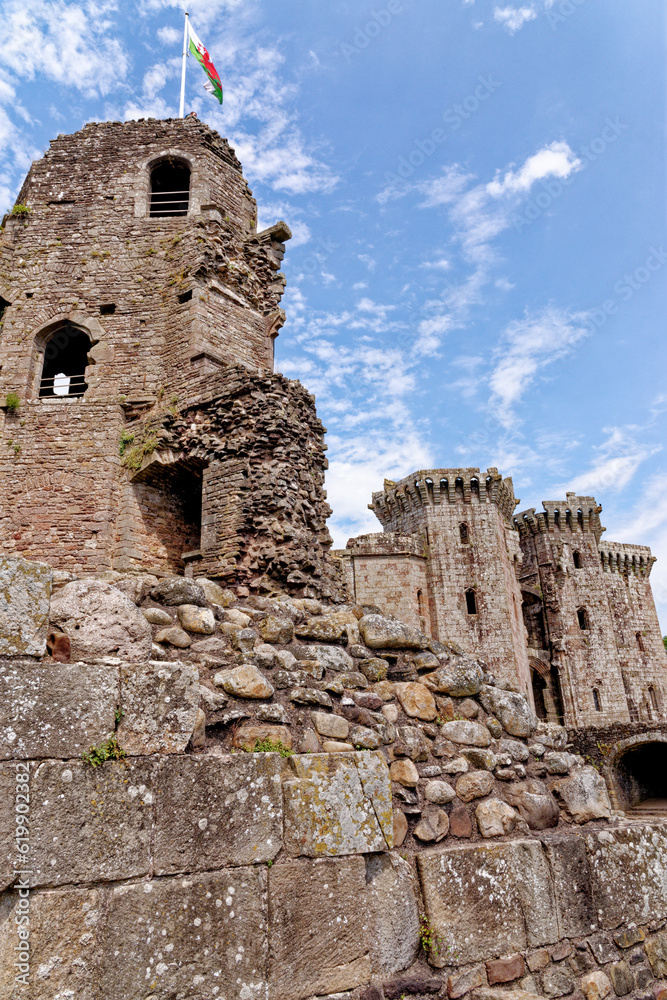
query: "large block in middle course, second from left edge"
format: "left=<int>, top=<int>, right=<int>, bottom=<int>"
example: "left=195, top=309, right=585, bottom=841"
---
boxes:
left=30, top=760, right=155, bottom=886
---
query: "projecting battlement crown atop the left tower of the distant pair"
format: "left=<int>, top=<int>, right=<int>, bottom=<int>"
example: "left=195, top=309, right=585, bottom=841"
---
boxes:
left=368, top=468, right=520, bottom=525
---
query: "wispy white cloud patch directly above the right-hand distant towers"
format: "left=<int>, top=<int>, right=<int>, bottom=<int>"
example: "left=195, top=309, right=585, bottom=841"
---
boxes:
left=488, top=306, right=591, bottom=426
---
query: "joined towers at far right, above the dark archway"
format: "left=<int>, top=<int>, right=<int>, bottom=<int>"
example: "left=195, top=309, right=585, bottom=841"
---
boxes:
left=516, top=493, right=667, bottom=726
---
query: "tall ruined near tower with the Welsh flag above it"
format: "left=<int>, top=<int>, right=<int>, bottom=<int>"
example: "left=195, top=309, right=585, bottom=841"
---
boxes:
left=0, top=117, right=342, bottom=593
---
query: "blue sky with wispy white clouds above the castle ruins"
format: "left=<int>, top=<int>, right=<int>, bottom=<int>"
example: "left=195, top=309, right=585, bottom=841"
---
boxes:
left=0, top=0, right=667, bottom=629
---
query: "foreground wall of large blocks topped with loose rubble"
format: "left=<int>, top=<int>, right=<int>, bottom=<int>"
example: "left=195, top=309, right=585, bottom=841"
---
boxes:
left=0, top=563, right=667, bottom=1000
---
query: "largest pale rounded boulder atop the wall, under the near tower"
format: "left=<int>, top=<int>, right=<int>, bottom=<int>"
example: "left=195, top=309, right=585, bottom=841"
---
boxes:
left=50, top=580, right=152, bottom=663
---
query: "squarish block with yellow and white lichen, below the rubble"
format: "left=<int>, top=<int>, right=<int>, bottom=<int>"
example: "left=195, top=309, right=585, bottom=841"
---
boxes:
left=283, top=752, right=393, bottom=857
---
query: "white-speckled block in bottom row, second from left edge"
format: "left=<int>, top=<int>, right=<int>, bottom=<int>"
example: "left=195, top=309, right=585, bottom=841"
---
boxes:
left=100, top=866, right=267, bottom=1000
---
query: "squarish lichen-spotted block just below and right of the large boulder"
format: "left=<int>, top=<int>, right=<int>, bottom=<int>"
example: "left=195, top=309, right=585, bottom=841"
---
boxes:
left=117, top=660, right=199, bottom=756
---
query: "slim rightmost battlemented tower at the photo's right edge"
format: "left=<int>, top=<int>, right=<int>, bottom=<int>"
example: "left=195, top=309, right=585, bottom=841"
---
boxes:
left=600, top=542, right=667, bottom=722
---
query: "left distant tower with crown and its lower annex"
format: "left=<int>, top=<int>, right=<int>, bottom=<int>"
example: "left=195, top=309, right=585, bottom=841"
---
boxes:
left=345, top=469, right=531, bottom=697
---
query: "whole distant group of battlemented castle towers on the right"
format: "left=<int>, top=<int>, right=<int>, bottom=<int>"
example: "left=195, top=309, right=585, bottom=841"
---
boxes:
left=336, top=468, right=667, bottom=726
